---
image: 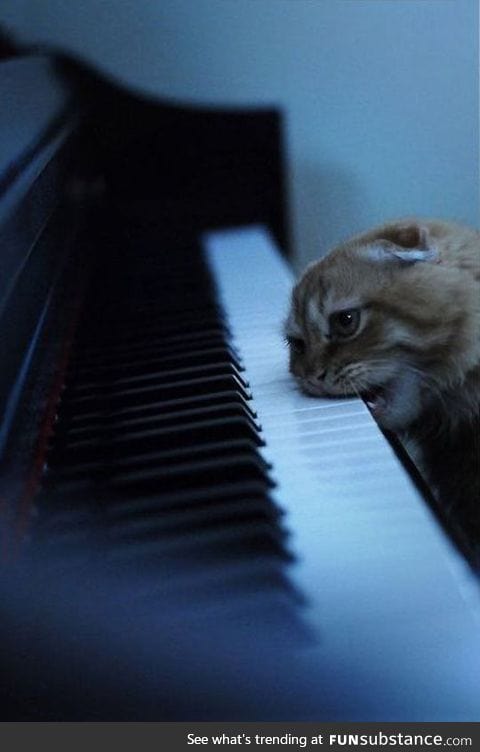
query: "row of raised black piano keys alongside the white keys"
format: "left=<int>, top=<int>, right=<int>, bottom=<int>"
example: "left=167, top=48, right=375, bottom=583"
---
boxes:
left=31, top=216, right=305, bottom=637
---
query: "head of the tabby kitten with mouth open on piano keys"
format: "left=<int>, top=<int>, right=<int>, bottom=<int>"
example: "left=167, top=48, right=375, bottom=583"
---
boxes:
left=285, top=222, right=474, bottom=430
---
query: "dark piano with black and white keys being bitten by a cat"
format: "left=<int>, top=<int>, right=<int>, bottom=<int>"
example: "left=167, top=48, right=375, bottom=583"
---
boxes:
left=0, top=50, right=480, bottom=722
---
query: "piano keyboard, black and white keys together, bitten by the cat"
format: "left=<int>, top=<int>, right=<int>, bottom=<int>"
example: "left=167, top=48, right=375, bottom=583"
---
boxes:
left=17, top=220, right=480, bottom=720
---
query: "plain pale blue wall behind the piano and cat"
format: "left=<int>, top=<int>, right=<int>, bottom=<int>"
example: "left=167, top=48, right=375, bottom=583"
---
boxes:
left=0, top=0, right=480, bottom=267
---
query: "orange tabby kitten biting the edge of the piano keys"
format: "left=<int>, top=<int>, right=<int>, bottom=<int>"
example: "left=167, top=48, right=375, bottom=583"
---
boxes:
left=285, top=218, right=480, bottom=566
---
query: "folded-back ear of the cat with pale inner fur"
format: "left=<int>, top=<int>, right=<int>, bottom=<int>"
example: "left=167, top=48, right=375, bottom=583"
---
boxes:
left=360, top=224, right=438, bottom=264
